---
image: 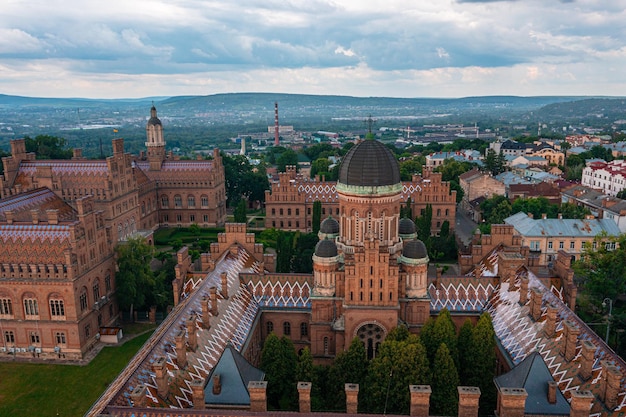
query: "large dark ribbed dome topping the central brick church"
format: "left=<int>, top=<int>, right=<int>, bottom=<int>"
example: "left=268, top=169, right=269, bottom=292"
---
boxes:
left=338, top=140, right=400, bottom=187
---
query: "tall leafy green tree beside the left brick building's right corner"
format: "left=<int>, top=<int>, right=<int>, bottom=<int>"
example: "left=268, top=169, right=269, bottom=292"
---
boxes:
left=115, top=238, right=154, bottom=320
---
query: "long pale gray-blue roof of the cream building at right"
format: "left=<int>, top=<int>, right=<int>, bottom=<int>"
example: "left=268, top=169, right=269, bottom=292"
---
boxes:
left=504, top=212, right=621, bottom=238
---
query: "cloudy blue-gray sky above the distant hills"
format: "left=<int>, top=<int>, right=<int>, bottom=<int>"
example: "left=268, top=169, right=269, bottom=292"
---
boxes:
left=0, top=0, right=626, bottom=98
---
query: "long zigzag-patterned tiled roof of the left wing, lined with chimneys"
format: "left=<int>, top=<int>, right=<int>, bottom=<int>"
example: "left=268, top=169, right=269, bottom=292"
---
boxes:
left=87, top=248, right=259, bottom=416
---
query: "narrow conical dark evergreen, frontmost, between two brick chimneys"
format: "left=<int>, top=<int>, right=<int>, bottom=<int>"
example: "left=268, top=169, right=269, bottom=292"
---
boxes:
left=430, top=343, right=458, bottom=416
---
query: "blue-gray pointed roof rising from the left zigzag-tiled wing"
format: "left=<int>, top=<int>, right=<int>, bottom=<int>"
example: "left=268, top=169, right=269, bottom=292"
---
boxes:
left=204, top=343, right=265, bottom=406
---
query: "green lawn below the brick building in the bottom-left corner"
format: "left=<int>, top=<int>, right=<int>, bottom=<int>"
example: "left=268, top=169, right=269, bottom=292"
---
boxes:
left=0, top=332, right=151, bottom=417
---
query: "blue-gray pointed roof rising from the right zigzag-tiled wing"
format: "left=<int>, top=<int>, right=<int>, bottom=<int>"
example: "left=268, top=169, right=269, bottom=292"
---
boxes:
left=494, top=351, right=570, bottom=415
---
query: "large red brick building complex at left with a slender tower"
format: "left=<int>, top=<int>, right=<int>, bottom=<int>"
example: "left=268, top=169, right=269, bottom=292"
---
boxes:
left=0, top=107, right=226, bottom=359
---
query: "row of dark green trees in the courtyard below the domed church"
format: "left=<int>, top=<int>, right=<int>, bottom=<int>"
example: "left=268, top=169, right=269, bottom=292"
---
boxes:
left=261, top=309, right=496, bottom=415
